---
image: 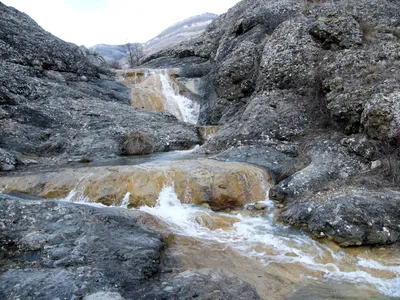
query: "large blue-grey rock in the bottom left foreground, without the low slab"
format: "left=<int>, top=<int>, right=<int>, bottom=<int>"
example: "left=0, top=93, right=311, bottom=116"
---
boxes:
left=0, top=195, right=163, bottom=299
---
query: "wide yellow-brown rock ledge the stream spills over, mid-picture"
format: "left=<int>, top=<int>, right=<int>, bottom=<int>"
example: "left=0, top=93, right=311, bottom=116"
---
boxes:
left=0, top=159, right=269, bottom=210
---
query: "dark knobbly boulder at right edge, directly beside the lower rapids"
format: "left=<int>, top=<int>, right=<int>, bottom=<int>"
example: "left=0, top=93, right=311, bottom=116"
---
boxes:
left=281, top=191, right=400, bottom=246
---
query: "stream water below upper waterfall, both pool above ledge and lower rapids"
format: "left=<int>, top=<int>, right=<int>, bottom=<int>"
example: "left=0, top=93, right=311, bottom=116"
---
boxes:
left=4, top=150, right=400, bottom=299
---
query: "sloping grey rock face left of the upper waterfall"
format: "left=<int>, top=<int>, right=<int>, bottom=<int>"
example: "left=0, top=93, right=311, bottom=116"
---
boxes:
left=0, top=4, right=200, bottom=170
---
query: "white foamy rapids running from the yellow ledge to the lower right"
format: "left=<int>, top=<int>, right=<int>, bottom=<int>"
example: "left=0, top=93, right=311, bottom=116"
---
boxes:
left=139, top=185, right=400, bottom=297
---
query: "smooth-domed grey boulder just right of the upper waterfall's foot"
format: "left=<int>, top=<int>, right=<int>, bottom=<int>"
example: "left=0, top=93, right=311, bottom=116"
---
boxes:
left=203, top=90, right=311, bottom=152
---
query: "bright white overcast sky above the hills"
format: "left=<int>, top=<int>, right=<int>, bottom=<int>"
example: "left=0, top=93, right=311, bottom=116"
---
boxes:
left=0, top=0, right=239, bottom=47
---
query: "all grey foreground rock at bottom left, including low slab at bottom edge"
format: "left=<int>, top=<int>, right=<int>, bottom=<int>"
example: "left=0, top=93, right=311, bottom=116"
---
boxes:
left=0, top=195, right=259, bottom=300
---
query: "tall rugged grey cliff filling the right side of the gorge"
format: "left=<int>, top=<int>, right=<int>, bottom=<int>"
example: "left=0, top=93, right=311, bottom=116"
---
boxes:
left=145, top=0, right=400, bottom=245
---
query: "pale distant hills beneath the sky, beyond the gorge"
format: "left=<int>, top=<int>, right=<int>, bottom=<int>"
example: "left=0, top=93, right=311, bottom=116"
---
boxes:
left=90, top=13, right=218, bottom=65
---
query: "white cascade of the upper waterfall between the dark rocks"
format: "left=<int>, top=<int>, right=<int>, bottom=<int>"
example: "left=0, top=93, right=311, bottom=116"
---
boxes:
left=152, top=70, right=200, bottom=124
